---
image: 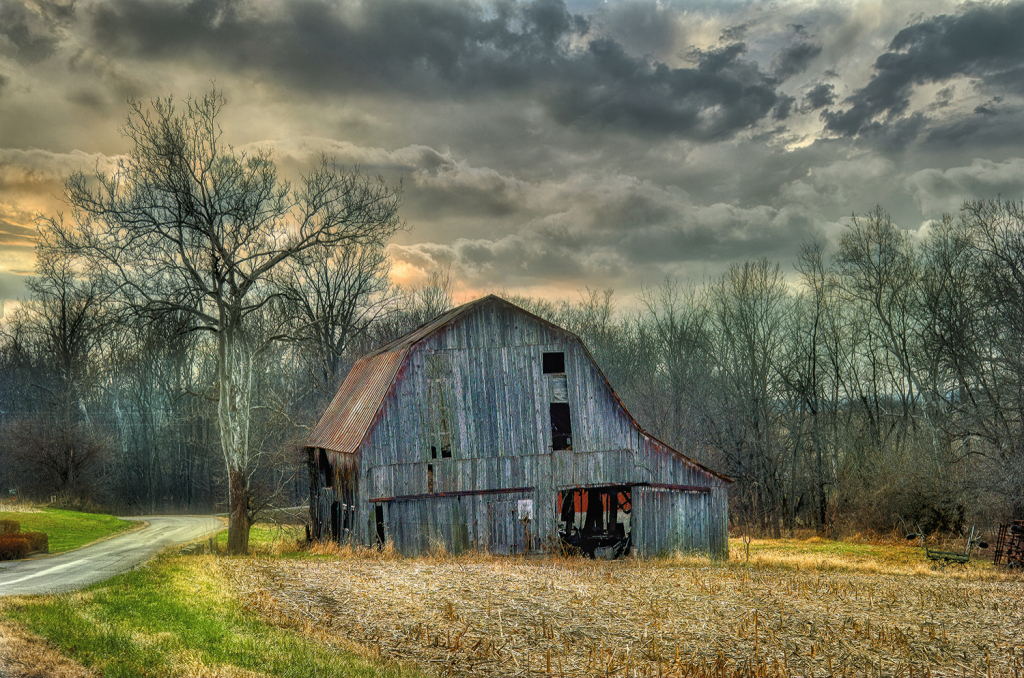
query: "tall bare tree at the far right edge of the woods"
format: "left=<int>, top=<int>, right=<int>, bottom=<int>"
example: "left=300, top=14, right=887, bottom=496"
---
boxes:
left=922, top=201, right=1024, bottom=515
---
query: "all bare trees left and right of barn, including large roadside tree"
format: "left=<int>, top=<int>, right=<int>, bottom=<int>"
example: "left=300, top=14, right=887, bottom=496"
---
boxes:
left=0, top=92, right=1024, bottom=552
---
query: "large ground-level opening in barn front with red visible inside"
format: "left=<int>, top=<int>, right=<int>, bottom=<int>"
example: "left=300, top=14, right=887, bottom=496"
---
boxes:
left=557, top=486, right=633, bottom=558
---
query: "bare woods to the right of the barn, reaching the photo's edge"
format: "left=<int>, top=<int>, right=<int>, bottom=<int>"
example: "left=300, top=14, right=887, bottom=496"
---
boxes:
left=520, top=200, right=1024, bottom=537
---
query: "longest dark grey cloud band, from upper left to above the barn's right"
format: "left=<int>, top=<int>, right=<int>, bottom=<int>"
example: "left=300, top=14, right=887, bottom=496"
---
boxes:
left=83, top=0, right=782, bottom=139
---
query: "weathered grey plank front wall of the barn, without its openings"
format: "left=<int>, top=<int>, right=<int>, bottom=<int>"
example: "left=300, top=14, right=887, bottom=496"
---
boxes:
left=311, top=300, right=726, bottom=554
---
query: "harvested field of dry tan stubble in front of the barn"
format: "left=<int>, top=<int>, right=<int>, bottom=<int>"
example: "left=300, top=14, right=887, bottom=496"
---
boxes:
left=224, top=540, right=1024, bottom=678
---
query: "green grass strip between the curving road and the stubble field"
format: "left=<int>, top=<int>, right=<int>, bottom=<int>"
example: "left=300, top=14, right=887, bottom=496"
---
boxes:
left=0, top=556, right=420, bottom=677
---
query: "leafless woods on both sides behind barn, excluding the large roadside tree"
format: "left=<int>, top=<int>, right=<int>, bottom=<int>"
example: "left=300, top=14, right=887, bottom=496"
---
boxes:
left=0, top=201, right=1024, bottom=535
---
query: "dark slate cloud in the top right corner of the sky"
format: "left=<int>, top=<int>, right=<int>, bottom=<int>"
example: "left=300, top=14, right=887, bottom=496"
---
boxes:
left=822, top=2, right=1024, bottom=136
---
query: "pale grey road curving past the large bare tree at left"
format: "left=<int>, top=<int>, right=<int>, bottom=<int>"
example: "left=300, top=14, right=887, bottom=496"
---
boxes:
left=0, top=515, right=223, bottom=596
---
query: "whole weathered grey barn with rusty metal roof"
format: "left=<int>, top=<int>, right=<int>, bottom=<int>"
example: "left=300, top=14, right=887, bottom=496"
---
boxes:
left=306, top=296, right=731, bottom=558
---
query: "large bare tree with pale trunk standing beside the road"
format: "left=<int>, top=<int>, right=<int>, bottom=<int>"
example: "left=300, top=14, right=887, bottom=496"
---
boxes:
left=41, top=91, right=399, bottom=553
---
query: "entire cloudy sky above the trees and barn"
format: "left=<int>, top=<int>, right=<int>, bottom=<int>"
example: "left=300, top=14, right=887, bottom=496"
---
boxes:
left=0, top=0, right=1024, bottom=313
